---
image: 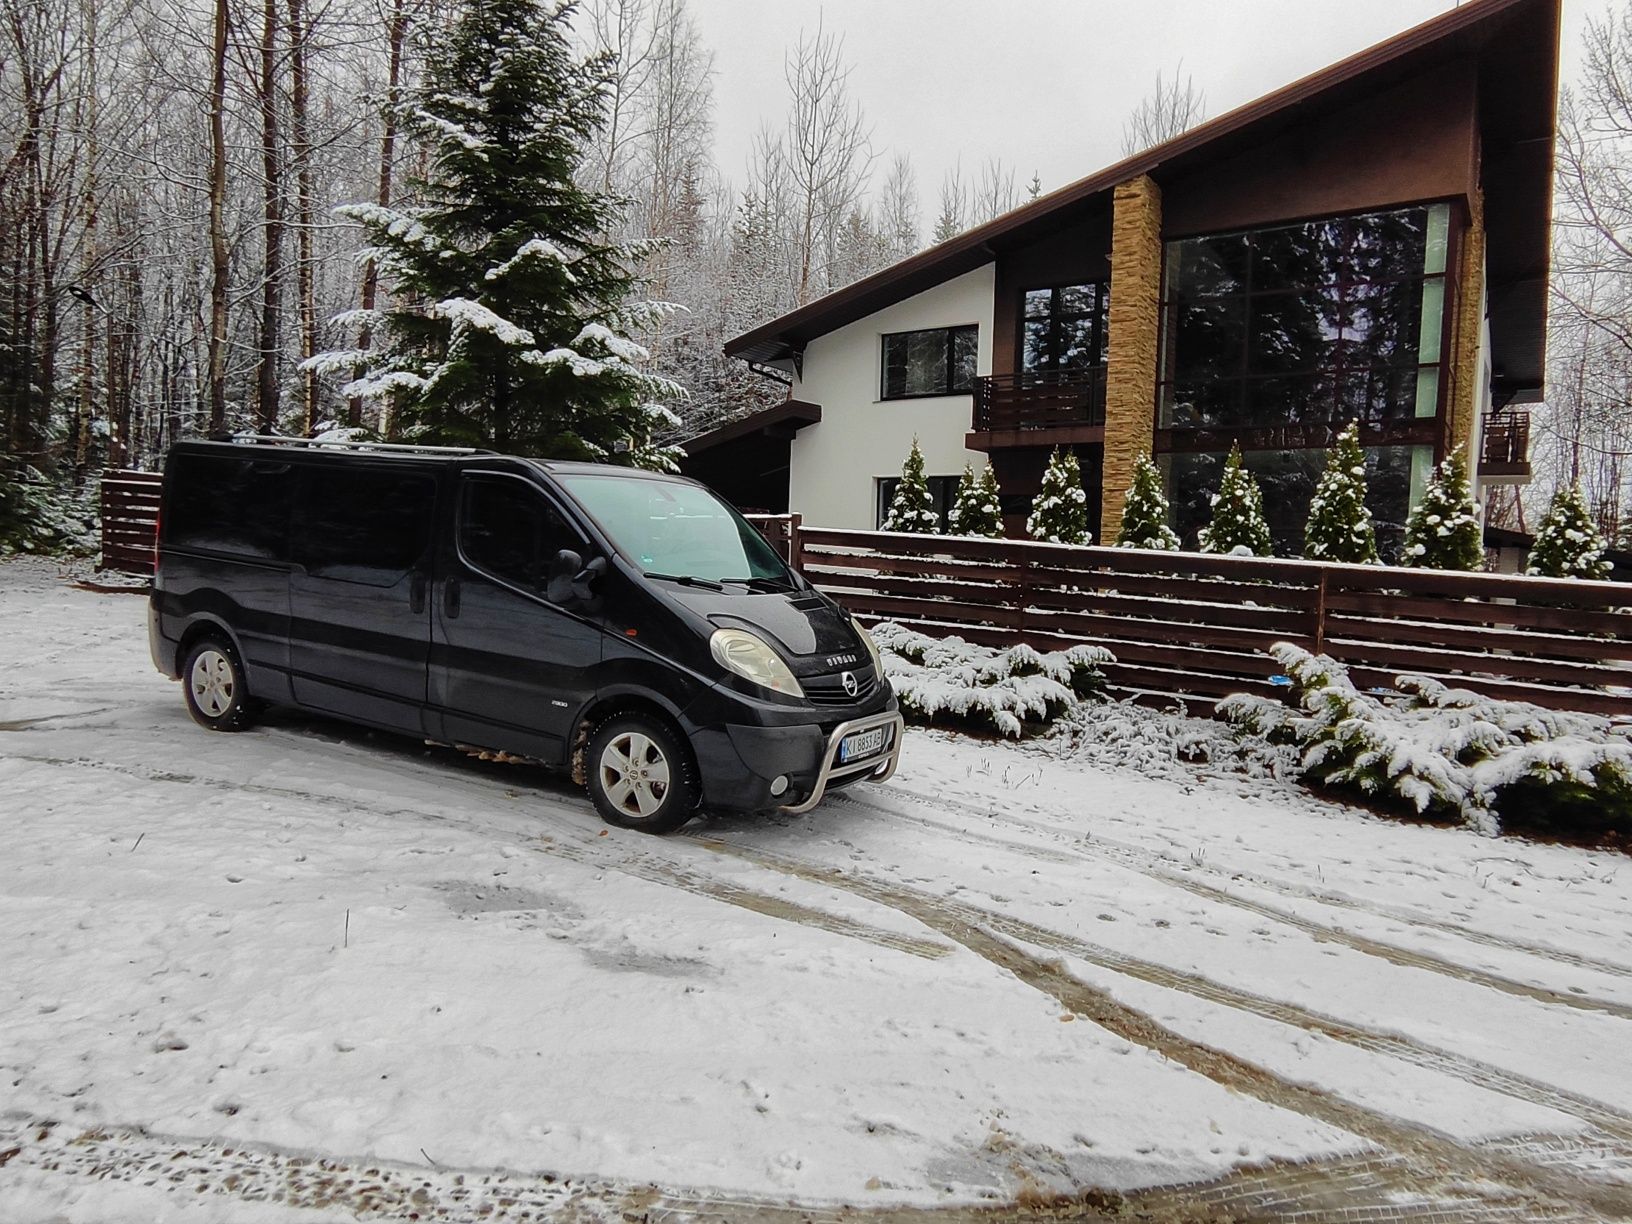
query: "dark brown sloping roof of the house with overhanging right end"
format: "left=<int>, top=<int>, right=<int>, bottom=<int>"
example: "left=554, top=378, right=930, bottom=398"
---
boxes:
left=725, top=0, right=1559, bottom=398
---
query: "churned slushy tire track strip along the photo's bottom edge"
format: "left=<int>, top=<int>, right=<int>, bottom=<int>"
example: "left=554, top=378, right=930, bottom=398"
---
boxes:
left=0, top=1118, right=1598, bottom=1224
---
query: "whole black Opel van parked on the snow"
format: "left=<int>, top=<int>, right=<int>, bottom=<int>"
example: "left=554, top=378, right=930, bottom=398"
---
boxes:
left=149, top=439, right=901, bottom=832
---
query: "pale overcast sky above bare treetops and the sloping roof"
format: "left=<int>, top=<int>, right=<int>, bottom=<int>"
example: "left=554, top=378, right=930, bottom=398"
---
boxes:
left=689, top=0, right=1599, bottom=218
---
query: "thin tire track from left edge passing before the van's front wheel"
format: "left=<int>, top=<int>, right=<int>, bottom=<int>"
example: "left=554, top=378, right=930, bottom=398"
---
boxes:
left=0, top=752, right=951, bottom=960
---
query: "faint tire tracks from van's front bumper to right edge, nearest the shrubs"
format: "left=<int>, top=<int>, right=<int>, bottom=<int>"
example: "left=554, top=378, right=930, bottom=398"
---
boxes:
left=839, top=780, right=1632, bottom=985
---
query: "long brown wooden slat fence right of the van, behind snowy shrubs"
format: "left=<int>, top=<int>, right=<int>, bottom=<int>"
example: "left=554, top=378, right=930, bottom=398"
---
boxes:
left=796, top=527, right=1632, bottom=715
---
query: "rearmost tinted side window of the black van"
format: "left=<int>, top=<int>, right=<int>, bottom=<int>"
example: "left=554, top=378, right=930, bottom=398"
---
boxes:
left=165, top=455, right=295, bottom=561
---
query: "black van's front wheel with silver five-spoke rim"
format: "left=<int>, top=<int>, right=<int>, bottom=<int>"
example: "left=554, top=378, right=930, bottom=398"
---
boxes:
left=584, top=715, right=700, bottom=832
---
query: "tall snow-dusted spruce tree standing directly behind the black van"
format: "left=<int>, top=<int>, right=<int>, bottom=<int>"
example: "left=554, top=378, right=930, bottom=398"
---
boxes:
left=308, top=0, right=684, bottom=468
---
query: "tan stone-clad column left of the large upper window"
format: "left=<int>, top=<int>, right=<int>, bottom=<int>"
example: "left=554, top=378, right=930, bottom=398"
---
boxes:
left=1097, top=175, right=1162, bottom=543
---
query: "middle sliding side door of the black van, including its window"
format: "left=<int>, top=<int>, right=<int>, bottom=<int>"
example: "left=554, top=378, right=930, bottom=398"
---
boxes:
left=289, top=462, right=437, bottom=734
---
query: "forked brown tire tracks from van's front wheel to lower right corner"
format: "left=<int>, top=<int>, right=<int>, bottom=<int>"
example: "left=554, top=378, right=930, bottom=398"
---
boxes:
left=695, top=837, right=1632, bottom=1219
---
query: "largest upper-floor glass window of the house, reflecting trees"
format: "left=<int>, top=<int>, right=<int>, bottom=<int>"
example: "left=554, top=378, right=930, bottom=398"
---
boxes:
left=1160, top=204, right=1449, bottom=429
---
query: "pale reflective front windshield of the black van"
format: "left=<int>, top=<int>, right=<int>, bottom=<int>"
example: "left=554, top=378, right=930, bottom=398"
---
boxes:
left=557, top=472, right=792, bottom=586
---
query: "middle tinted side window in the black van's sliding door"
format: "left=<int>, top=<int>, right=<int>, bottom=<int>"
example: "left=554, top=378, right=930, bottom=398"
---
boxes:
left=294, top=465, right=436, bottom=586
